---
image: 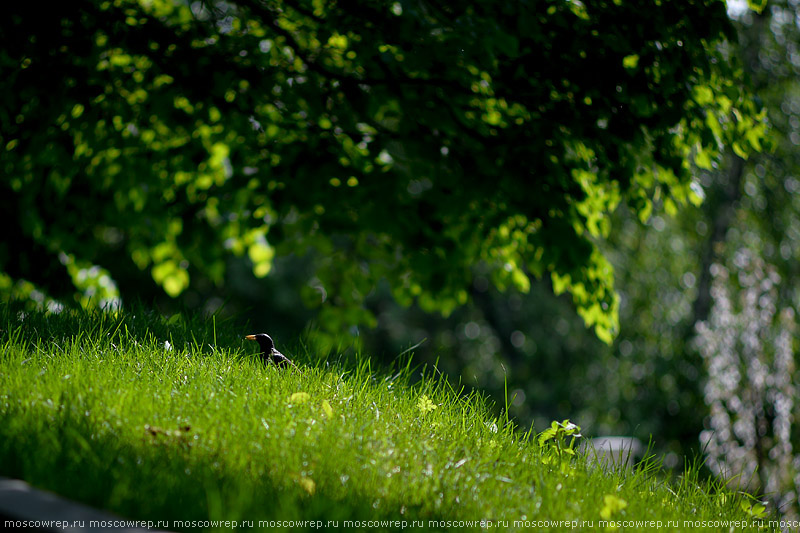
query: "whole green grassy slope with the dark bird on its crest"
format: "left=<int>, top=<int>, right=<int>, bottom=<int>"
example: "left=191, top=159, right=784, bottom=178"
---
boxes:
left=0, top=305, right=776, bottom=531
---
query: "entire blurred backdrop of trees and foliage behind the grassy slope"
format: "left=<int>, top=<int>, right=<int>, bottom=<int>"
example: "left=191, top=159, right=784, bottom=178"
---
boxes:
left=0, top=0, right=800, bottom=514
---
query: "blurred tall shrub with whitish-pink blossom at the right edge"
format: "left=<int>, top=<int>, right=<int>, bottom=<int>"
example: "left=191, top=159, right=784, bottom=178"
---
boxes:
left=697, top=249, right=800, bottom=518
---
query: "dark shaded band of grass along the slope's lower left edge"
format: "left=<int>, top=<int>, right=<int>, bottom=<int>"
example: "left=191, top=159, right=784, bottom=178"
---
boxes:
left=0, top=402, right=445, bottom=531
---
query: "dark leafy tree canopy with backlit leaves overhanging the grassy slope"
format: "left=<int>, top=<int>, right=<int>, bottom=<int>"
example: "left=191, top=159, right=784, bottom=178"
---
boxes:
left=0, top=0, right=763, bottom=340
